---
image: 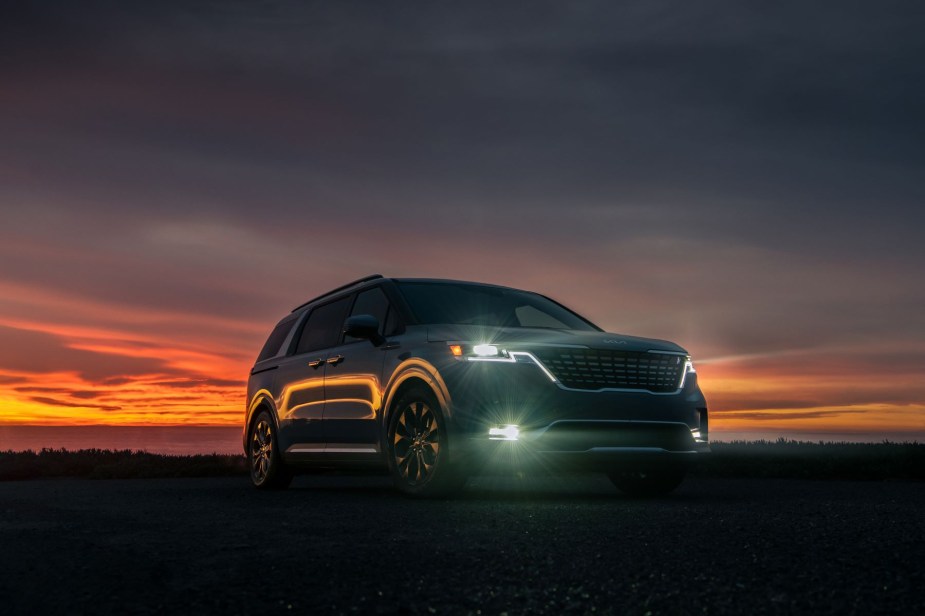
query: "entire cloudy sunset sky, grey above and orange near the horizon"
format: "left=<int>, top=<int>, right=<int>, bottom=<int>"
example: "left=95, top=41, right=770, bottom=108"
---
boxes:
left=0, top=0, right=925, bottom=441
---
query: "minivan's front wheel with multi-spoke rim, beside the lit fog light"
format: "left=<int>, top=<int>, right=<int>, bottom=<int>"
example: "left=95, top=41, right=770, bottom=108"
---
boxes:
left=387, top=386, right=466, bottom=498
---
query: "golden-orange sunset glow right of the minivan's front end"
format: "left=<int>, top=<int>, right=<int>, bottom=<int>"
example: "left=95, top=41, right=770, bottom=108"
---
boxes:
left=698, top=347, right=925, bottom=439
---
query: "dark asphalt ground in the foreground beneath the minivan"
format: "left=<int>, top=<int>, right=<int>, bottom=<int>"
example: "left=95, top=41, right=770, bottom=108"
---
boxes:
left=0, top=475, right=925, bottom=614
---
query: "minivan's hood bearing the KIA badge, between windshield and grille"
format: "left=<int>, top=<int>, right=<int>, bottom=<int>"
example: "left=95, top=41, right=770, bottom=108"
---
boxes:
left=427, top=325, right=687, bottom=353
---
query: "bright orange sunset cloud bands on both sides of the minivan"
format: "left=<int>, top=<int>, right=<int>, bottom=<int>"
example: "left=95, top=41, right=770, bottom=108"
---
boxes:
left=0, top=282, right=925, bottom=438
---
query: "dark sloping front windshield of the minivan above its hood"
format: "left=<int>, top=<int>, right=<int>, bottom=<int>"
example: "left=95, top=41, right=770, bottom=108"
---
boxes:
left=398, top=282, right=600, bottom=331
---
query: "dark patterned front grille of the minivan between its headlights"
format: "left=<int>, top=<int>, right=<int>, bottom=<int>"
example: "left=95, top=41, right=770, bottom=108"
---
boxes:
left=533, top=347, right=685, bottom=393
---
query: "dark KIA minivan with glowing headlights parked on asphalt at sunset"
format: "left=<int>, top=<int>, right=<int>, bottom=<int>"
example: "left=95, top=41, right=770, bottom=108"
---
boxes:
left=243, top=275, right=710, bottom=496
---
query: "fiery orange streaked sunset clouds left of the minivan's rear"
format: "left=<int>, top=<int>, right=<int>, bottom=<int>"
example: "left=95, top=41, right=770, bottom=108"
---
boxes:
left=0, top=283, right=258, bottom=425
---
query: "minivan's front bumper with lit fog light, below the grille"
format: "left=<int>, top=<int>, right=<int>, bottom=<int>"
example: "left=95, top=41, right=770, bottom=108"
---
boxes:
left=445, top=364, right=710, bottom=471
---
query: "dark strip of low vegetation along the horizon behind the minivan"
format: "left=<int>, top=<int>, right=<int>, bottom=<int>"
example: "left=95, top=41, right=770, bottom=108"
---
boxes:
left=0, top=439, right=925, bottom=481
